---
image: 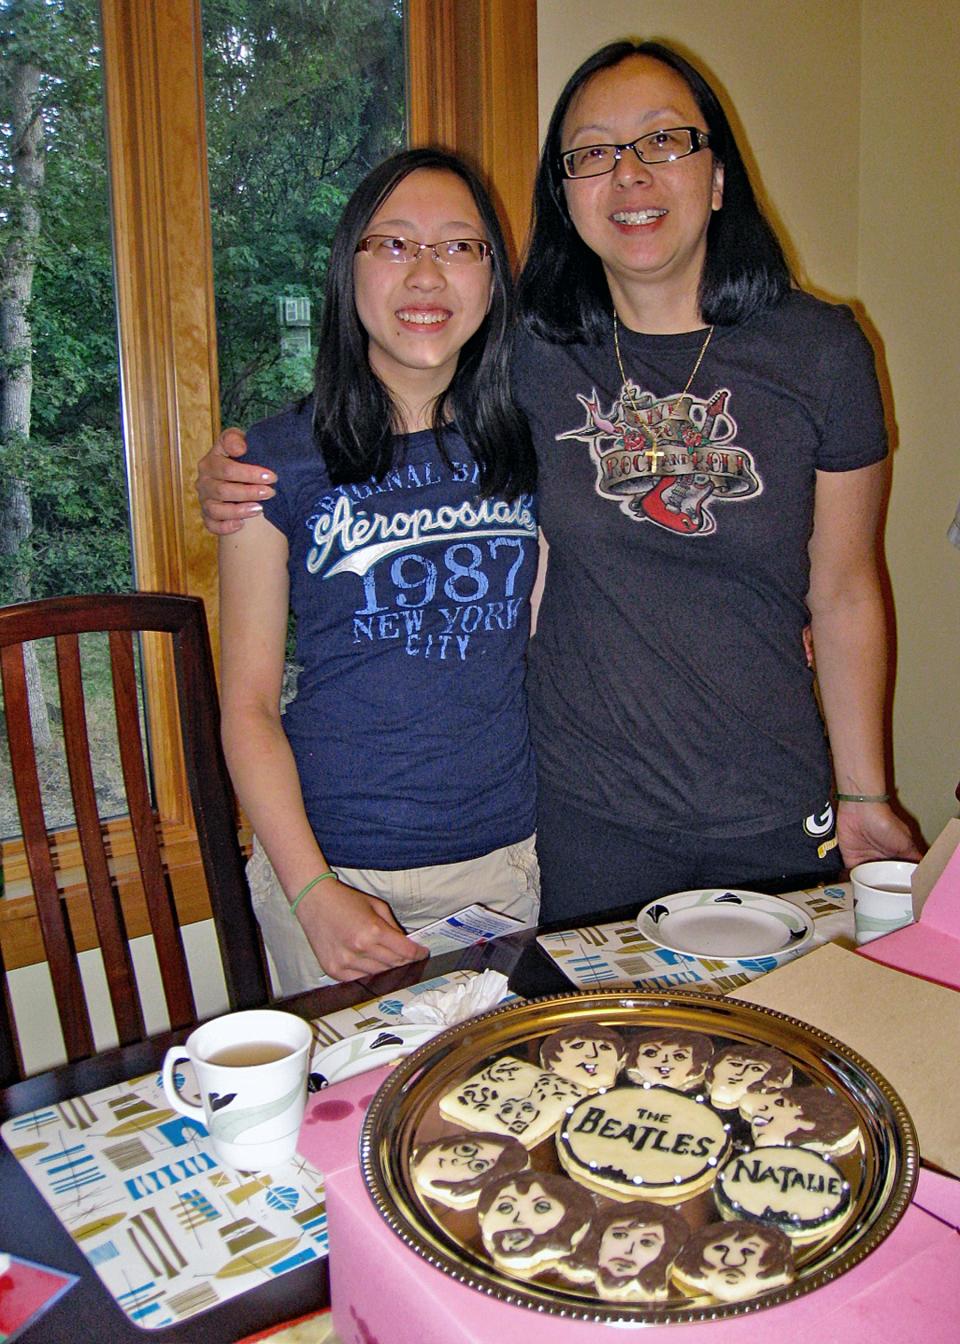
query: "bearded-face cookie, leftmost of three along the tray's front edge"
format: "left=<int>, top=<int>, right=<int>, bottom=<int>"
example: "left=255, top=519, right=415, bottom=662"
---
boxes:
left=477, top=1171, right=596, bottom=1277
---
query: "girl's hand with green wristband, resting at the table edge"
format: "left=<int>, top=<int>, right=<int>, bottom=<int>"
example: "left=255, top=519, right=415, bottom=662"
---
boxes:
left=296, top=882, right=426, bottom=980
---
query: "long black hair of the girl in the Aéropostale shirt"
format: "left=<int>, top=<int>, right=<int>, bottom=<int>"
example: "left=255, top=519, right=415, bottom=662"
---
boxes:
left=313, top=148, right=536, bottom=497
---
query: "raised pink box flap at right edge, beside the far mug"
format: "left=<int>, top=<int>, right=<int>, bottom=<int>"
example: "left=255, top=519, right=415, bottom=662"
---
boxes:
left=859, top=821, right=960, bottom=994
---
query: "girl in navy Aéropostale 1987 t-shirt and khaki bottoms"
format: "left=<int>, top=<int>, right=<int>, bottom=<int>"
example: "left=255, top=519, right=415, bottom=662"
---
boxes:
left=219, top=149, right=538, bottom=993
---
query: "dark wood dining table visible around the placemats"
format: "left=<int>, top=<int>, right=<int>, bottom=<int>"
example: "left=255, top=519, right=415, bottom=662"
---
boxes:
left=0, top=911, right=567, bottom=1344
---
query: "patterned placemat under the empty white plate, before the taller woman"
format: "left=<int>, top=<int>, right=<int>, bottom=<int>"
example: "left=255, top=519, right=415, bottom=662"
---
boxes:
left=536, top=883, right=854, bottom=995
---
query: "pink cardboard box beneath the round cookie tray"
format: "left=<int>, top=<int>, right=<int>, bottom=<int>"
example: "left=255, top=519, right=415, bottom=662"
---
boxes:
left=300, top=1070, right=960, bottom=1344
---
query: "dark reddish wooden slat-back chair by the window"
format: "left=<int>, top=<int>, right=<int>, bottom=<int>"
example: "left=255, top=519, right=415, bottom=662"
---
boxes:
left=0, top=593, right=269, bottom=1085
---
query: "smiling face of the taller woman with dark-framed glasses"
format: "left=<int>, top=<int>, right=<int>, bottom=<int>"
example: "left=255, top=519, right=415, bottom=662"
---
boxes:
left=562, top=55, right=723, bottom=323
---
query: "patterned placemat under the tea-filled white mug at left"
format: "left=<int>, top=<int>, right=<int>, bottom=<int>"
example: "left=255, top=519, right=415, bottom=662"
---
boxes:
left=0, top=970, right=476, bottom=1329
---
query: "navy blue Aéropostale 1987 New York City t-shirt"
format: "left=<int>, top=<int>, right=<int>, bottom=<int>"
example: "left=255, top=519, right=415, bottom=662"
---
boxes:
left=247, top=406, right=536, bottom=870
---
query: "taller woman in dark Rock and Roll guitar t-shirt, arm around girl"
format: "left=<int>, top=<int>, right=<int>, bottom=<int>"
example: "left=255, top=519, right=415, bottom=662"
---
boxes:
left=200, top=42, right=917, bottom=919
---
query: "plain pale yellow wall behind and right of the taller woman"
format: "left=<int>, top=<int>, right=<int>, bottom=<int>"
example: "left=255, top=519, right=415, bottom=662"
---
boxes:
left=538, top=0, right=960, bottom=841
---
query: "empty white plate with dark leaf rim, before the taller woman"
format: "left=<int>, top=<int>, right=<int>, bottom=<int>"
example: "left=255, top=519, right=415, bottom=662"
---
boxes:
left=637, top=887, right=813, bottom=961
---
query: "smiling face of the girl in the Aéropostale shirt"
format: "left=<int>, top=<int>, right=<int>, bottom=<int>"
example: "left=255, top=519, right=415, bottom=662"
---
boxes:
left=354, top=168, right=492, bottom=416
